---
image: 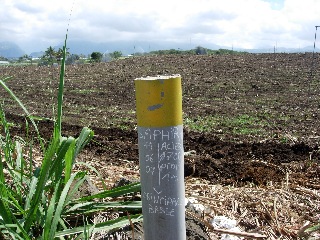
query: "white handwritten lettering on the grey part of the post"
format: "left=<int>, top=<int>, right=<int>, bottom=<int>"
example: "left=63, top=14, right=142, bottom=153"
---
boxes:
left=138, top=127, right=184, bottom=216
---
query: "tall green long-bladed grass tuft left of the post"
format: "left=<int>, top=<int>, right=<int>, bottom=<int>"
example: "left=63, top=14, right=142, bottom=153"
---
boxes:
left=0, top=32, right=142, bottom=239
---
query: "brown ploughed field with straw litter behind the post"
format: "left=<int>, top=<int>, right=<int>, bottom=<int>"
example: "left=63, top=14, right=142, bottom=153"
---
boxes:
left=0, top=53, right=320, bottom=239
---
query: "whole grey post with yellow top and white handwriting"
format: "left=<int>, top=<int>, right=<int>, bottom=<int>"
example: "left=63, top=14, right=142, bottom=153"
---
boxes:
left=135, top=75, right=186, bottom=240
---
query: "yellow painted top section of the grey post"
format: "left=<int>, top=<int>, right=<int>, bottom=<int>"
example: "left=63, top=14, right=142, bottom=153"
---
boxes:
left=135, top=74, right=182, bottom=127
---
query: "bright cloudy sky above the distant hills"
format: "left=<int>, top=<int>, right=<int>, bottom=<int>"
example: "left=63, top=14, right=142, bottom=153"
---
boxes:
left=0, top=0, right=320, bottom=52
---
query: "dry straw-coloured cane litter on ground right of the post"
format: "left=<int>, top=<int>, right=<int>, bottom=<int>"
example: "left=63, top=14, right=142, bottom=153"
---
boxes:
left=186, top=178, right=320, bottom=240
